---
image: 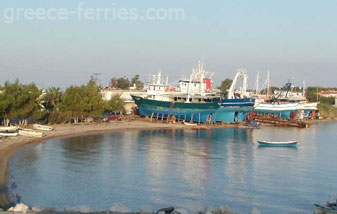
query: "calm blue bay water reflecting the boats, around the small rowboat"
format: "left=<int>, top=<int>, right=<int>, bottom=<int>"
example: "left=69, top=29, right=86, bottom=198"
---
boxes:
left=10, top=123, right=337, bottom=214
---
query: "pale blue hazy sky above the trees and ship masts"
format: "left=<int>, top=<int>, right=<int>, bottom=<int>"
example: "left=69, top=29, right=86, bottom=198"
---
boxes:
left=0, top=0, right=337, bottom=88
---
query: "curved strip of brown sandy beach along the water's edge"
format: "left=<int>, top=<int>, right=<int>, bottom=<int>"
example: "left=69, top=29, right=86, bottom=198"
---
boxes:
left=0, top=121, right=188, bottom=209
